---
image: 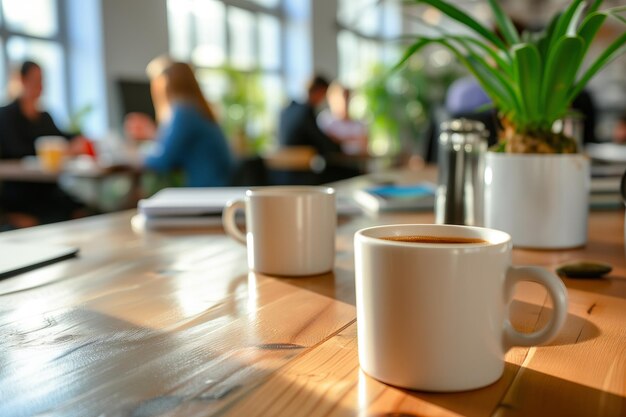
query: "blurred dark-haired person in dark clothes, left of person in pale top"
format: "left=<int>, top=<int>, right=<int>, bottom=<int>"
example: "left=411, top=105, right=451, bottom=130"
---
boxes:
left=278, top=76, right=341, bottom=155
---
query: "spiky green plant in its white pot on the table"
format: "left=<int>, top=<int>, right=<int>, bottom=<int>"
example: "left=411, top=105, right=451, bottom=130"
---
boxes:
left=398, top=0, right=626, bottom=248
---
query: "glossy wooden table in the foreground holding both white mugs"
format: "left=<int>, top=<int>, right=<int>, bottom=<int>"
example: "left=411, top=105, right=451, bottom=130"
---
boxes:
left=0, top=170, right=626, bottom=416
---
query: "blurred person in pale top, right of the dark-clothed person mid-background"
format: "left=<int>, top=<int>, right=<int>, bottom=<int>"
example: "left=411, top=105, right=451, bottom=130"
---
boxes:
left=317, top=82, right=368, bottom=155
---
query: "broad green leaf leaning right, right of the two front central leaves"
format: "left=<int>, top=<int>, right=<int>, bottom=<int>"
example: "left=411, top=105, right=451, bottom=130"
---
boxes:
left=541, top=36, right=584, bottom=121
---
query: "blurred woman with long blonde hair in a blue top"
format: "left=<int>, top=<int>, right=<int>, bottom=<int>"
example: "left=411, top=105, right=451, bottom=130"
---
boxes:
left=124, top=57, right=235, bottom=187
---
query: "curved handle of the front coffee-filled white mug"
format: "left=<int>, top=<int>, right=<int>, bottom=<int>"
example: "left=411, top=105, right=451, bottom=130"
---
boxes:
left=504, top=266, right=567, bottom=350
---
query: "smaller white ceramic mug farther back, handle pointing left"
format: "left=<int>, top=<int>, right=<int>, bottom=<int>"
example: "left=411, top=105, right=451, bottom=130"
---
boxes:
left=222, top=186, right=337, bottom=276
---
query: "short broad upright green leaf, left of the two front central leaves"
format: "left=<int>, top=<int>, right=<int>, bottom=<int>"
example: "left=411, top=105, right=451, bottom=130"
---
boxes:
left=513, top=43, right=543, bottom=123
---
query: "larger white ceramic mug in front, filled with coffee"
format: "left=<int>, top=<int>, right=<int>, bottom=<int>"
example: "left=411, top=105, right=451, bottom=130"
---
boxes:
left=354, top=225, right=567, bottom=391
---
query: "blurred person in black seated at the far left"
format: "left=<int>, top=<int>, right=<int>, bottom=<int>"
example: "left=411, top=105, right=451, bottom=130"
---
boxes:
left=0, top=61, right=83, bottom=227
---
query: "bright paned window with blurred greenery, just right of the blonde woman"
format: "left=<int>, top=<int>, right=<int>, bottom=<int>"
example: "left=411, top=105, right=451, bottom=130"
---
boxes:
left=167, top=0, right=284, bottom=153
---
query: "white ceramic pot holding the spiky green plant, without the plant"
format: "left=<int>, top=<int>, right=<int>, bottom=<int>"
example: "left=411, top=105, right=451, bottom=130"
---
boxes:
left=485, top=152, right=590, bottom=249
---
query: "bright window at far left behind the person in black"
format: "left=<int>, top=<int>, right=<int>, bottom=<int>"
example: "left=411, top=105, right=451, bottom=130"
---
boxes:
left=0, top=0, right=68, bottom=121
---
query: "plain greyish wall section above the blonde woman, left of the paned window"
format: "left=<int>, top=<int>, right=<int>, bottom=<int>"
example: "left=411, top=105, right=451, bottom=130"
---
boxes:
left=100, top=0, right=169, bottom=129
